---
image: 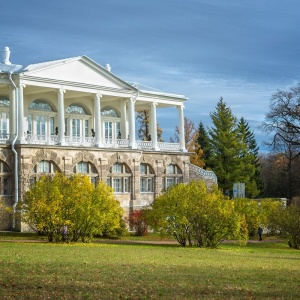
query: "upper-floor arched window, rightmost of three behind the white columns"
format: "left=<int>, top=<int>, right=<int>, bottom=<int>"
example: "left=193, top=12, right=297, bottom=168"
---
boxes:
left=101, top=106, right=119, bottom=143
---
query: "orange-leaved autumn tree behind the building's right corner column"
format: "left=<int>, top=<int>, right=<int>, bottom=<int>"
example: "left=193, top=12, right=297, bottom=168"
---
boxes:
left=170, top=117, right=204, bottom=168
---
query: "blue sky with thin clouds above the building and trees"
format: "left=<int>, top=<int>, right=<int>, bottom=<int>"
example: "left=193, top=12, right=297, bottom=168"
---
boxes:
left=0, top=0, right=300, bottom=152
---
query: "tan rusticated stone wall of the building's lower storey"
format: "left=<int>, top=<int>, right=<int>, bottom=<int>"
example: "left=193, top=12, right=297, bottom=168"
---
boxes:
left=0, top=145, right=197, bottom=230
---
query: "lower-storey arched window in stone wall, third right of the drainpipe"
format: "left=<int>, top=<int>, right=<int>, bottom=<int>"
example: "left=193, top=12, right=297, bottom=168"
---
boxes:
left=107, top=162, right=131, bottom=193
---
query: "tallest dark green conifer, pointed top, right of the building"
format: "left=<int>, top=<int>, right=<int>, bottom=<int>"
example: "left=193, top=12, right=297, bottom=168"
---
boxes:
left=207, top=98, right=243, bottom=194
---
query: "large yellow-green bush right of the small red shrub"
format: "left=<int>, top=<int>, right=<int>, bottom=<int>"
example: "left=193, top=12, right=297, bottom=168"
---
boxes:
left=148, top=181, right=245, bottom=248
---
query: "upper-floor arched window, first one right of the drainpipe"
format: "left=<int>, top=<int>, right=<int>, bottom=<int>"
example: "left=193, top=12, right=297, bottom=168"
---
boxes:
left=27, top=99, right=57, bottom=135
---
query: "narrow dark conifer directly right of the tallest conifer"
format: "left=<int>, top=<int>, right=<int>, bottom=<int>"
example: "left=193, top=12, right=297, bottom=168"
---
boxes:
left=238, top=117, right=262, bottom=198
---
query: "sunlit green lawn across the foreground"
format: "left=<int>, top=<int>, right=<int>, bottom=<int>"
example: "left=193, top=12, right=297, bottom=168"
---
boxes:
left=0, top=234, right=300, bottom=299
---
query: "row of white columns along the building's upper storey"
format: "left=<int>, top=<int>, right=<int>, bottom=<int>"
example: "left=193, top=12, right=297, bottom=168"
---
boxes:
left=9, top=84, right=186, bottom=152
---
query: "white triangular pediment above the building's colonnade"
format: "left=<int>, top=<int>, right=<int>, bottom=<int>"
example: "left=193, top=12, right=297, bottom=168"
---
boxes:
left=25, top=56, right=132, bottom=89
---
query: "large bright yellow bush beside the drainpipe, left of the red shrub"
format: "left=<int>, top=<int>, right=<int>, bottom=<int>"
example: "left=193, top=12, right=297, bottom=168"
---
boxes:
left=22, top=173, right=123, bottom=242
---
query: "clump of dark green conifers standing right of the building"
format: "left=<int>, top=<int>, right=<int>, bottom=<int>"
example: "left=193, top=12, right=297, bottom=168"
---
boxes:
left=203, top=98, right=261, bottom=198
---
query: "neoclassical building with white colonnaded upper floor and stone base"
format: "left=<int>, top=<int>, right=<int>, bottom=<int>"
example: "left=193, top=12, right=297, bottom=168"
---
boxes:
left=0, top=47, right=216, bottom=230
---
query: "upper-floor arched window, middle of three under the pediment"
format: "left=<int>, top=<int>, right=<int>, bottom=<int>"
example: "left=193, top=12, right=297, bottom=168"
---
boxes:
left=65, top=104, right=92, bottom=141
